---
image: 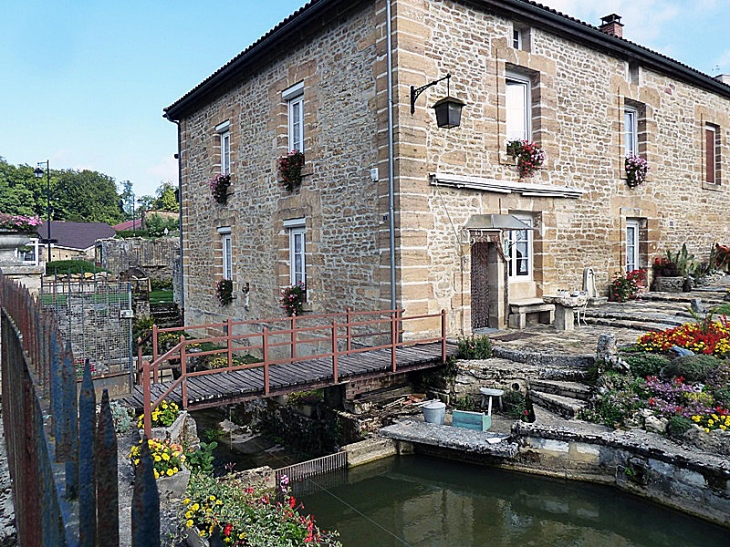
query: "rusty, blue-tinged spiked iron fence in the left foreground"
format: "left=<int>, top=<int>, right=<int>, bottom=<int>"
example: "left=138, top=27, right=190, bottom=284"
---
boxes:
left=0, top=274, right=160, bottom=547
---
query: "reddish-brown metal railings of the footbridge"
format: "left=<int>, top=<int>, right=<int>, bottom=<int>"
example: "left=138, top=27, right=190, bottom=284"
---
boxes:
left=138, top=309, right=447, bottom=435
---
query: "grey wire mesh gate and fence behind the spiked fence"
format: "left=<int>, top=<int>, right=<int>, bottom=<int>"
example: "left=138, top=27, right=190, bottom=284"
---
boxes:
left=40, top=274, right=134, bottom=382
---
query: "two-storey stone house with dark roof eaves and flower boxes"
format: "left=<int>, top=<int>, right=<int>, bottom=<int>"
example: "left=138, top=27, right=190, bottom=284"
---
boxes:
left=165, top=0, right=730, bottom=335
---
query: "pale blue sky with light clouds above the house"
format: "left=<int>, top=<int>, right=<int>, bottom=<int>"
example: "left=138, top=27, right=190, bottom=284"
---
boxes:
left=0, top=0, right=730, bottom=195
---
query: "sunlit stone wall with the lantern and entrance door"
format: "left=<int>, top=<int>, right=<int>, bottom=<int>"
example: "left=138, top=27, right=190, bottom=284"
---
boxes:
left=396, top=0, right=730, bottom=332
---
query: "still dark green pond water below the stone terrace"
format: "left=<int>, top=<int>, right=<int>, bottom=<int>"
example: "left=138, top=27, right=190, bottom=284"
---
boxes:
left=294, top=456, right=730, bottom=547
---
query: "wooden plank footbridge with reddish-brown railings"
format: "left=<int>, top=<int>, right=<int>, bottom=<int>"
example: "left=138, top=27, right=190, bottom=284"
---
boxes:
left=122, top=310, right=456, bottom=435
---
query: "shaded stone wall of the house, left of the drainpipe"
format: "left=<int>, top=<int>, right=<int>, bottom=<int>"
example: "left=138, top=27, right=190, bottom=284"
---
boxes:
left=181, top=3, right=387, bottom=323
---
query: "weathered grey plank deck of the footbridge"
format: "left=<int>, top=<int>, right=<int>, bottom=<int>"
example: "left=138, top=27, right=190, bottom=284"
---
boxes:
left=125, top=342, right=456, bottom=411
